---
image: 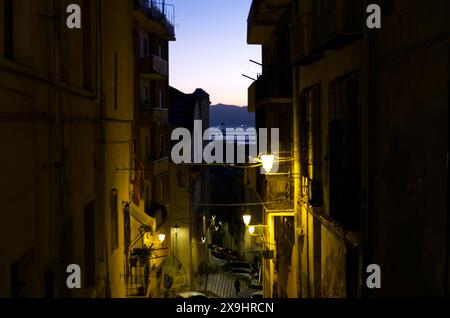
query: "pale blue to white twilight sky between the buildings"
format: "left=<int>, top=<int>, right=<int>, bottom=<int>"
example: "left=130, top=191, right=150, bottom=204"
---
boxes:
left=166, top=0, right=261, bottom=106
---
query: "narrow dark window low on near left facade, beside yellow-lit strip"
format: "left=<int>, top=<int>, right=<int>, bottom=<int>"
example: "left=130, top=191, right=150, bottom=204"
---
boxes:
left=84, top=201, right=96, bottom=287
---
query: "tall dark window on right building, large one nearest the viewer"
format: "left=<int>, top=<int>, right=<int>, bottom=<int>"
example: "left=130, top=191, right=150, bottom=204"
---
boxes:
left=329, top=74, right=362, bottom=230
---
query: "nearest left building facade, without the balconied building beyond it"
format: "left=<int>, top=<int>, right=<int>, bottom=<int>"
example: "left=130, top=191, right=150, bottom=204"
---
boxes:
left=0, top=0, right=133, bottom=297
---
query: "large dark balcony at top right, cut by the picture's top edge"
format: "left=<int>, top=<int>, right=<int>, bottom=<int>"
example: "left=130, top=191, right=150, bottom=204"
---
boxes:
left=313, top=0, right=364, bottom=50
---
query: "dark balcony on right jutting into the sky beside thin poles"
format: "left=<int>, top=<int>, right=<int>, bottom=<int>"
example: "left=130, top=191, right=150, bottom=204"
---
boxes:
left=248, top=68, right=292, bottom=112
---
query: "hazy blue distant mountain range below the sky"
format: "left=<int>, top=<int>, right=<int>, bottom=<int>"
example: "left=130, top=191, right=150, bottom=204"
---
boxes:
left=209, top=104, right=255, bottom=128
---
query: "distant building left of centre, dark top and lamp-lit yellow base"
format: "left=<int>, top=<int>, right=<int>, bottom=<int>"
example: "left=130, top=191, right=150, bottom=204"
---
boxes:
left=167, top=87, right=211, bottom=292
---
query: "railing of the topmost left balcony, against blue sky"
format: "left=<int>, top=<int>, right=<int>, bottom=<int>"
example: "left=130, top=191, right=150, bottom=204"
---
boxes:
left=134, top=0, right=175, bottom=35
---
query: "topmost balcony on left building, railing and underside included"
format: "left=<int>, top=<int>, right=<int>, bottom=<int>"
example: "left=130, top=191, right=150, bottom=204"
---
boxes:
left=134, top=0, right=175, bottom=41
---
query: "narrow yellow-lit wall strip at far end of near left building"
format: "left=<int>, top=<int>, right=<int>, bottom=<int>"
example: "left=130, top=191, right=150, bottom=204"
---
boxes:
left=102, top=0, right=134, bottom=297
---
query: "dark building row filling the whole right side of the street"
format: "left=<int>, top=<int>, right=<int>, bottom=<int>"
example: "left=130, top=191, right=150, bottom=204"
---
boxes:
left=248, top=0, right=449, bottom=298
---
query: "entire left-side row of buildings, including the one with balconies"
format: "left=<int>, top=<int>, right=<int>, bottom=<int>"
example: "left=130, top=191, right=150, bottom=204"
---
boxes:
left=0, top=0, right=178, bottom=298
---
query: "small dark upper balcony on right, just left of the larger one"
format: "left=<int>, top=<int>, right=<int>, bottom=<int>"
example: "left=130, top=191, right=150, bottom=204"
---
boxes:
left=290, top=12, right=323, bottom=65
